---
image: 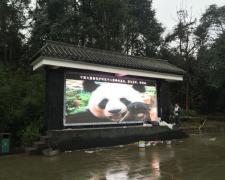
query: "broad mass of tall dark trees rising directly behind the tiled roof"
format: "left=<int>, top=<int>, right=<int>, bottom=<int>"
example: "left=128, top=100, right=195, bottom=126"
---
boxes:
left=30, top=0, right=163, bottom=56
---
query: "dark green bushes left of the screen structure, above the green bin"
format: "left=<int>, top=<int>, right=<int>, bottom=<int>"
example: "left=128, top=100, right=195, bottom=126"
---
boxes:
left=0, top=65, right=44, bottom=146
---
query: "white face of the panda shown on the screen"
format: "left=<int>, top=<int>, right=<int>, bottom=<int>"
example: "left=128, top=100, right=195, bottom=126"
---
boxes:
left=88, top=83, right=143, bottom=121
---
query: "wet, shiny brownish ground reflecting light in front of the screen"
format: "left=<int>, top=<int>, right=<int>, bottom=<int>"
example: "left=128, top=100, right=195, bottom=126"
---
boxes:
left=0, top=133, right=225, bottom=180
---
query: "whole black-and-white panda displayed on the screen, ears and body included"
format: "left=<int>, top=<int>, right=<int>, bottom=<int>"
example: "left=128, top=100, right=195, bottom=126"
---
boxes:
left=68, top=80, right=150, bottom=122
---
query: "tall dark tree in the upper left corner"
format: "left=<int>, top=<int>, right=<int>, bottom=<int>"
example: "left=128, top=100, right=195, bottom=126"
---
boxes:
left=0, top=0, right=29, bottom=65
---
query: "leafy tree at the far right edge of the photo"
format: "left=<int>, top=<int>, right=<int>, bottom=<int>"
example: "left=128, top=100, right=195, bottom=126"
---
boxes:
left=196, top=5, right=225, bottom=88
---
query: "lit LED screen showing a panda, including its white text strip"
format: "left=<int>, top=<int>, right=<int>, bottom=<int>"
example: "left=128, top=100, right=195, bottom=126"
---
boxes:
left=64, top=73, right=157, bottom=126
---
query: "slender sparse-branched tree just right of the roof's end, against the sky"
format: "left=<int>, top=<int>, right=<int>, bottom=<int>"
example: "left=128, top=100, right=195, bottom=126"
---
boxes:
left=162, top=10, right=199, bottom=111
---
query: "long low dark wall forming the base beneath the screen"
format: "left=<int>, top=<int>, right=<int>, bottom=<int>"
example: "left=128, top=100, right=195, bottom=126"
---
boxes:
left=48, top=126, right=187, bottom=151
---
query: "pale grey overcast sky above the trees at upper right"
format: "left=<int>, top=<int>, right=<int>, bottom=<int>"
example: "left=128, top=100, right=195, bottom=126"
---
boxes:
left=152, top=0, right=225, bottom=32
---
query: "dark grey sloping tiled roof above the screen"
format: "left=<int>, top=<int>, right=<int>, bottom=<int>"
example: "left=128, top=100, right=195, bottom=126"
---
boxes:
left=32, top=41, right=185, bottom=75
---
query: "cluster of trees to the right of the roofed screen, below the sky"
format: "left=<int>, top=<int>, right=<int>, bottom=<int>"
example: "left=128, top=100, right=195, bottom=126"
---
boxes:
left=161, top=5, right=225, bottom=114
